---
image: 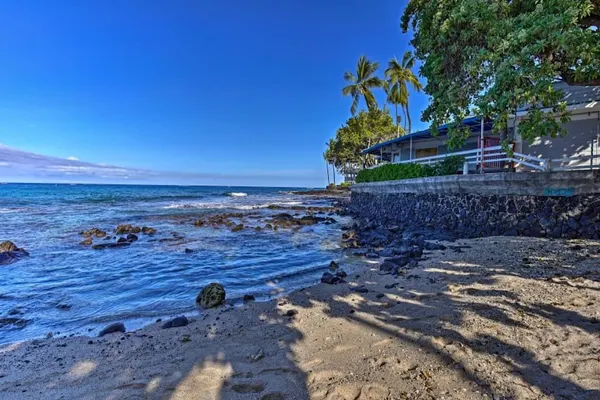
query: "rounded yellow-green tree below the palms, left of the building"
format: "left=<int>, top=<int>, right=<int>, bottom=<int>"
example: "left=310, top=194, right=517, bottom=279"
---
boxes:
left=325, top=108, right=396, bottom=172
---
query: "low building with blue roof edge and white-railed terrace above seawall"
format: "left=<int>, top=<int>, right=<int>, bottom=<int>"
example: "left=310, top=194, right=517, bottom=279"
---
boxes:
left=363, top=83, right=600, bottom=171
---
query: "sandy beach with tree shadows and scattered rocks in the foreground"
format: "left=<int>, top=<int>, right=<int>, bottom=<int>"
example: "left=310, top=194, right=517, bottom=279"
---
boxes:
left=0, top=237, right=600, bottom=400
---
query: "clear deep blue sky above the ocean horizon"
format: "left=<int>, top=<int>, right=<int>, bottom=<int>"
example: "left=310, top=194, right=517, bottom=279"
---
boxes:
left=0, top=0, right=427, bottom=186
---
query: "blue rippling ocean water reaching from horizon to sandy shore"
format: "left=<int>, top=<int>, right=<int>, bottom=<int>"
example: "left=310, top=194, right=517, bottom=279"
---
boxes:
left=0, top=184, right=342, bottom=343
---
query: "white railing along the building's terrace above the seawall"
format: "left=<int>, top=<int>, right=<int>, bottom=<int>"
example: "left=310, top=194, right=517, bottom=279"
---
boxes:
left=369, top=146, right=600, bottom=171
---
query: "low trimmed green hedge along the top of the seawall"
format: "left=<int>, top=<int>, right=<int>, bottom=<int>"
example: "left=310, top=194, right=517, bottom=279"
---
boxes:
left=356, top=156, right=465, bottom=183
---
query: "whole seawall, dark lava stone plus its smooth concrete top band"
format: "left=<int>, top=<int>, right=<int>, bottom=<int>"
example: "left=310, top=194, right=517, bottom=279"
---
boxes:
left=349, top=171, right=600, bottom=239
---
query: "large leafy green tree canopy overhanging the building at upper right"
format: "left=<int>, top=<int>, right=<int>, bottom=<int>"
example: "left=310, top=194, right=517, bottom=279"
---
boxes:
left=401, top=0, right=600, bottom=146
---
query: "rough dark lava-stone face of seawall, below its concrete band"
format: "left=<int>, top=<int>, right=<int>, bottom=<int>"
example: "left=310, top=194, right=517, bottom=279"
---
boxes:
left=349, top=190, right=600, bottom=239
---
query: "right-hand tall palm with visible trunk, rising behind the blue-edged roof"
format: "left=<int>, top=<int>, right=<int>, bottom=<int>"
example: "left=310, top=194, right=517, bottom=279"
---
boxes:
left=385, top=51, right=423, bottom=133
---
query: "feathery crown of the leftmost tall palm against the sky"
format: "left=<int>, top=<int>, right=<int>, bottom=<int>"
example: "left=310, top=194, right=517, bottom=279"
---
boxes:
left=342, top=56, right=383, bottom=115
